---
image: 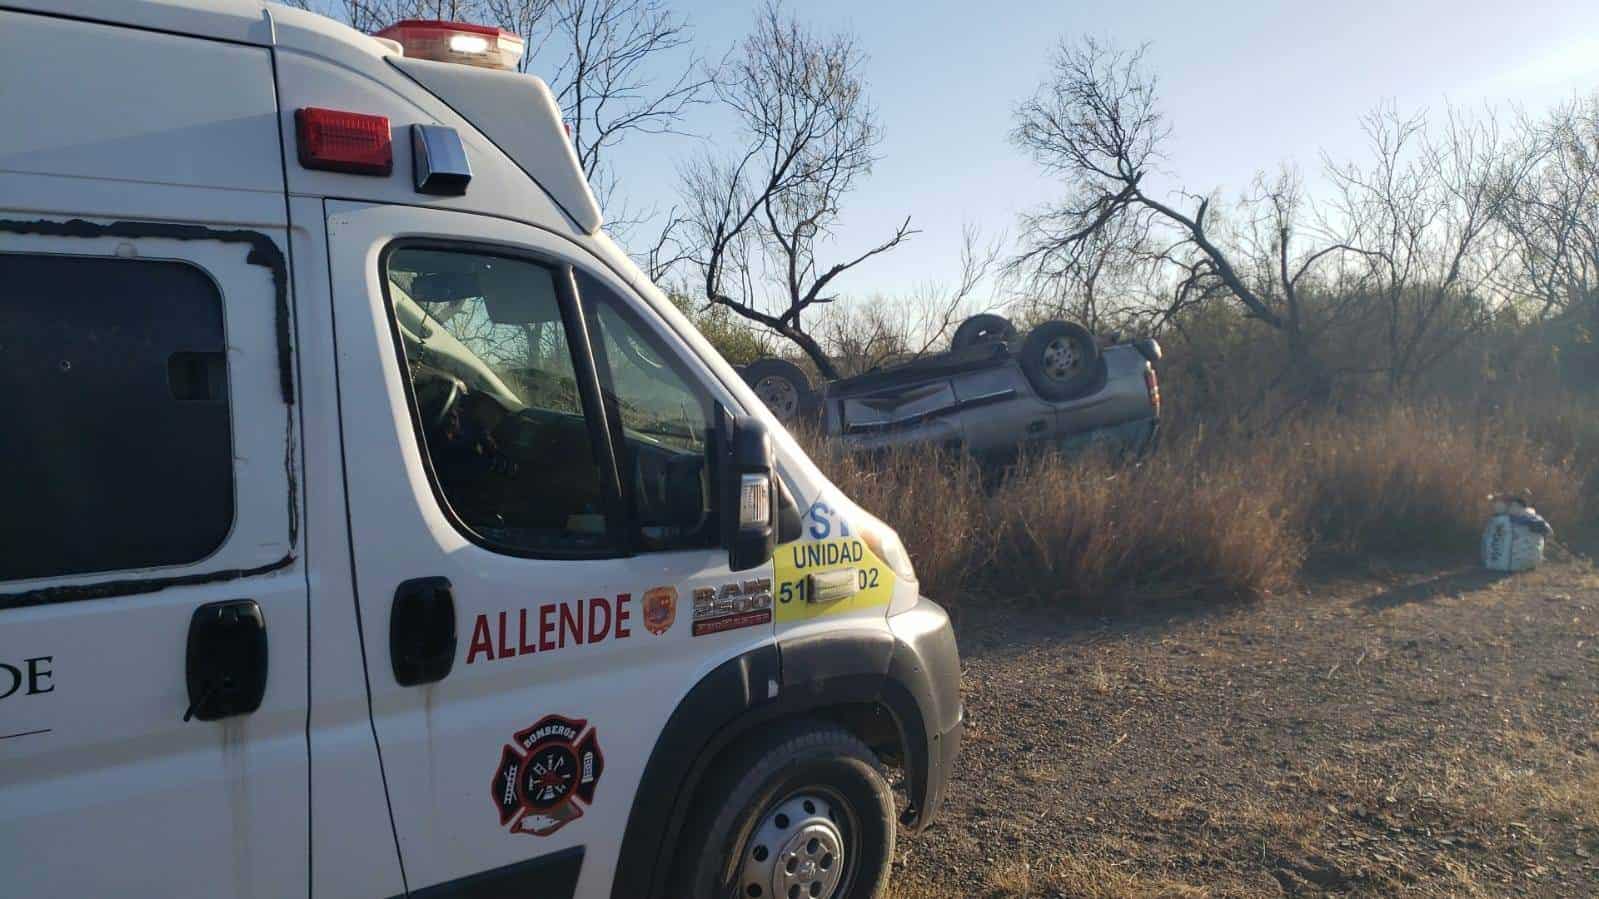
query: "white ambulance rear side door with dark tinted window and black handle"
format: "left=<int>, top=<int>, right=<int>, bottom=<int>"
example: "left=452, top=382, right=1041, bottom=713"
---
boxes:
left=0, top=227, right=309, bottom=897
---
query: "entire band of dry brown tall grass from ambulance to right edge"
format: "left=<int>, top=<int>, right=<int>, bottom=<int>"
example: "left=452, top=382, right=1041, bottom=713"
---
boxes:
left=803, top=399, right=1599, bottom=611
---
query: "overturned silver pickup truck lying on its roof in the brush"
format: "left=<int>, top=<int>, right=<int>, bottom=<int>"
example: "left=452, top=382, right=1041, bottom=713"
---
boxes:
left=742, top=315, right=1161, bottom=454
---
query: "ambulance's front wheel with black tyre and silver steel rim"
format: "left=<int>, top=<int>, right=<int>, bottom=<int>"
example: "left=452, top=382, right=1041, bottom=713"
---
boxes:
left=673, top=721, right=894, bottom=899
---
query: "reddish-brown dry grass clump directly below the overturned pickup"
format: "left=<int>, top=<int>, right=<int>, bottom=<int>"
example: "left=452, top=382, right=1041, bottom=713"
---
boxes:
left=804, top=419, right=1302, bottom=609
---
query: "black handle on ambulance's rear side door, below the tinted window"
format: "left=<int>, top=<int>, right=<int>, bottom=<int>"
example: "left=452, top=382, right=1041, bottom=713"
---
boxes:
left=184, top=600, right=267, bottom=721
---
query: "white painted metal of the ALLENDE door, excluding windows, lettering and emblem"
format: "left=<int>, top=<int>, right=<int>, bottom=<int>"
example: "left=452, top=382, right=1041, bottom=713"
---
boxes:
left=328, top=200, right=772, bottom=897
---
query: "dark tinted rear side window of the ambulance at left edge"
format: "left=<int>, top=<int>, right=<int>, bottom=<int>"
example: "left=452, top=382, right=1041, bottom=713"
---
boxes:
left=0, top=253, right=233, bottom=581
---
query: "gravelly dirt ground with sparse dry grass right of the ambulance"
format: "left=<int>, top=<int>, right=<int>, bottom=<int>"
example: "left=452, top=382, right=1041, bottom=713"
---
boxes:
left=891, top=550, right=1599, bottom=899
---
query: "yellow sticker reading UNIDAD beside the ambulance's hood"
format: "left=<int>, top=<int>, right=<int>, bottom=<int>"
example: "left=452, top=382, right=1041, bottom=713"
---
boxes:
left=772, top=537, right=894, bottom=622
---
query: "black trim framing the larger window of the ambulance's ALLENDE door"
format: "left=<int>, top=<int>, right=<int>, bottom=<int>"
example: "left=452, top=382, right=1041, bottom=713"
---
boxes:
left=377, top=237, right=638, bottom=560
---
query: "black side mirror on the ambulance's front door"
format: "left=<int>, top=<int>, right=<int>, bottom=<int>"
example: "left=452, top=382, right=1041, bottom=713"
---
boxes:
left=715, top=406, right=777, bottom=571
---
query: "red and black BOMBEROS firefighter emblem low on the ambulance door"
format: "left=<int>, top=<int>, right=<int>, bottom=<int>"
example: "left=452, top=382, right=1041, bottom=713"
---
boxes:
left=491, top=715, right=604, bottom=837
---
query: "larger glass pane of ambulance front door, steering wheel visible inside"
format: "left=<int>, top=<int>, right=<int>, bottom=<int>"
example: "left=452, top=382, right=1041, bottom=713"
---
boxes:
left=384, top=246, right=616, bottom=555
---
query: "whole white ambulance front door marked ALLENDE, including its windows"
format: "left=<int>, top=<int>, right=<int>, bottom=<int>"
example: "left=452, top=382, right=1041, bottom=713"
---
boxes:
left=326, top=202, right=772, bottom=899
